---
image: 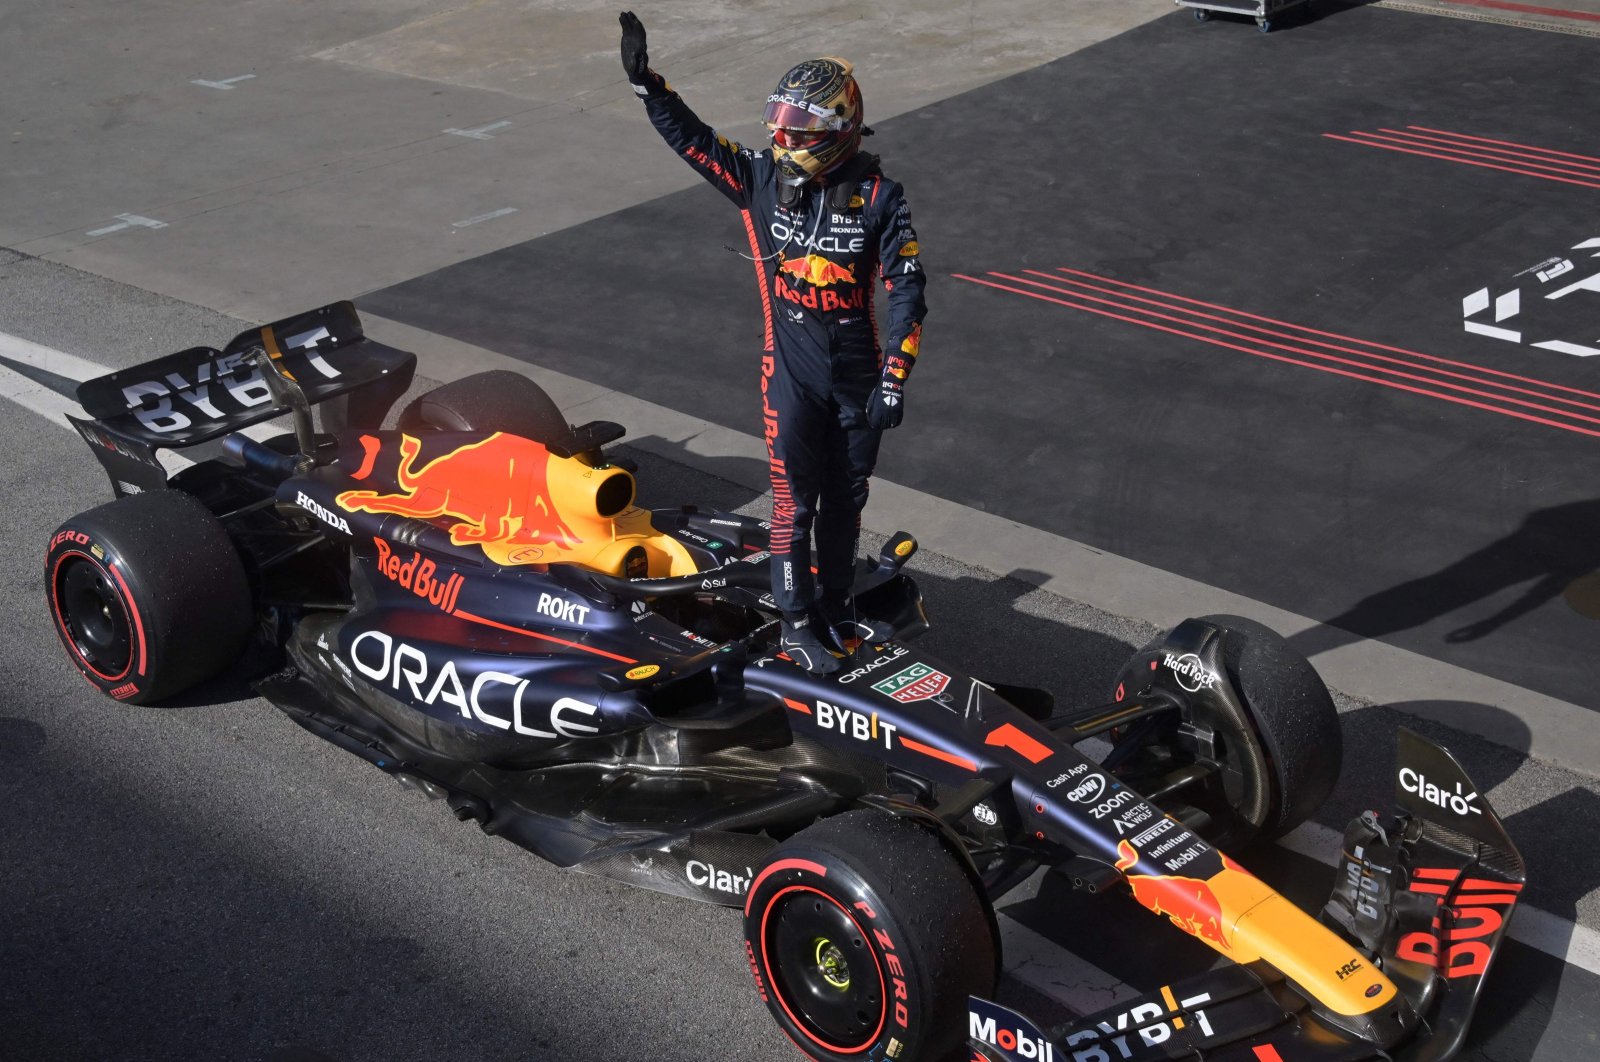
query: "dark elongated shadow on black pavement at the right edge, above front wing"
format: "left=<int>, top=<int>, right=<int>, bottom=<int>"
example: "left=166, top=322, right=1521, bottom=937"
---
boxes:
left=1290, top=499, right=1600, bottom=657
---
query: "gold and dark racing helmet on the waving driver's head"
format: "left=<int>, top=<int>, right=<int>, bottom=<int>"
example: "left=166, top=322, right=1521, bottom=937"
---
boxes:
left=762, top=59, right=861, bottom=184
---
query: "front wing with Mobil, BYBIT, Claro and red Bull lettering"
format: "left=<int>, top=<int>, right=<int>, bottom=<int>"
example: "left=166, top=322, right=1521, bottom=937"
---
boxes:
left=968, top=729, right=1526, bottom=1062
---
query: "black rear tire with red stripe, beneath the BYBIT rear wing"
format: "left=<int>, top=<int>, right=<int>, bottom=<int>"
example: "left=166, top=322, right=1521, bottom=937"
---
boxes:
left=45, top=491, right=253, bottom=704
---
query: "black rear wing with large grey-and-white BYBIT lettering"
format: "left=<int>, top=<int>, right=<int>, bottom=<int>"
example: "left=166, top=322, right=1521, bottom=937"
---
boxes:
left=69, top=301, right=416, bottom=494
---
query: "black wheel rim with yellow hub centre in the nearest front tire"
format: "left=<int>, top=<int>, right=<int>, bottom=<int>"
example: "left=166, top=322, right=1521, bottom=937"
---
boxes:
left=763, top=886, right=886, bottom=1054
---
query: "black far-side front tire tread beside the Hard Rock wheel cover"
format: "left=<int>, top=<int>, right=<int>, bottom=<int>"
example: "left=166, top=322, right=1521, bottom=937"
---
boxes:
left=1202, top=616, right=1344, bottom=840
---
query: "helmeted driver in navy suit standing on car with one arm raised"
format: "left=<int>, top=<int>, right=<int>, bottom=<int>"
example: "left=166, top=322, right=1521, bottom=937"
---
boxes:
left=621, top=11, right=926, bottom=673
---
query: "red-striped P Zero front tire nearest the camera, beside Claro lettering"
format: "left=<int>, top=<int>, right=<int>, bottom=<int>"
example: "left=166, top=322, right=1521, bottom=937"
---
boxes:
left=744, top=811, right=997, bottom=1062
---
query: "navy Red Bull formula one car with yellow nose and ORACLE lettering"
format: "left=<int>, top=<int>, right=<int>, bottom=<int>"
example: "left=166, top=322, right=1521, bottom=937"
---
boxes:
left=45, top=302, right=1523, bottom=1062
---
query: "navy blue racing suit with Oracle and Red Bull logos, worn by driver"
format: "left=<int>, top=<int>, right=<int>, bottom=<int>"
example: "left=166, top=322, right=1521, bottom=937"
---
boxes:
left=637, top=72, right=928, bottom=614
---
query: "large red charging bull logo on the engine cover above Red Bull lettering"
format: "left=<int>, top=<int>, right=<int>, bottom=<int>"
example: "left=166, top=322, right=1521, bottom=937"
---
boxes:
left=336, top=432, right=579, bottom=565
